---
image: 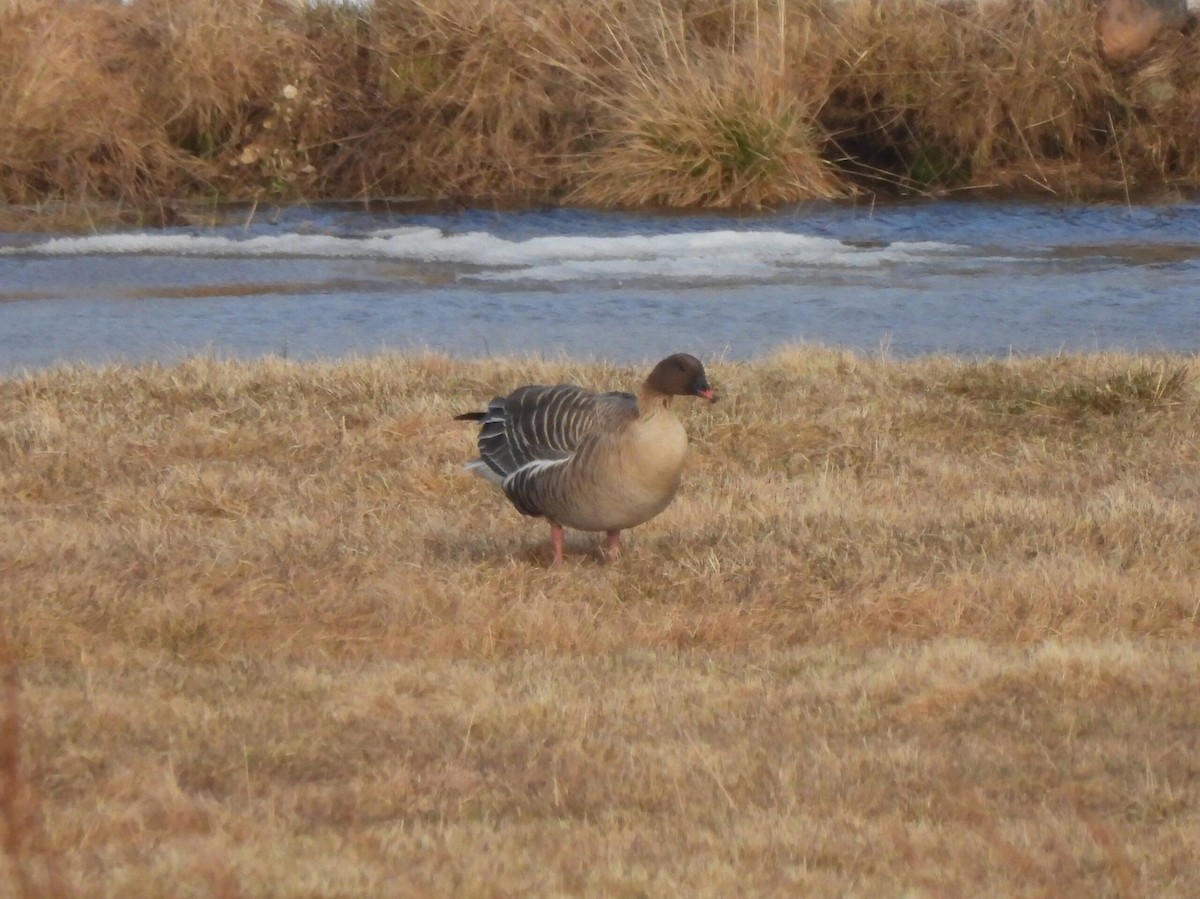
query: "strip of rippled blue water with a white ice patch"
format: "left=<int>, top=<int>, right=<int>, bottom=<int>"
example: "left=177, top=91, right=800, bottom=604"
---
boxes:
left=0, top=200, right=1200, bottom=373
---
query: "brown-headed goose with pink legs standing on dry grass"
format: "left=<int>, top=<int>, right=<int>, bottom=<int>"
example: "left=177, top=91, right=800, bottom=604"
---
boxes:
left=455, top=353, right=716, bottom=556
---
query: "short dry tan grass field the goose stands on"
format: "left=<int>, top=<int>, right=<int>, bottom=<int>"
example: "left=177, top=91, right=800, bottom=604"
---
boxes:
left=0, top=347, right=1200, bottom=899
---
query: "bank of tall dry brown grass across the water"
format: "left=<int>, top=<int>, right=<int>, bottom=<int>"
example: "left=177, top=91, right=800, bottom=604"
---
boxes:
left=0, top=0, right=1200, bottom=227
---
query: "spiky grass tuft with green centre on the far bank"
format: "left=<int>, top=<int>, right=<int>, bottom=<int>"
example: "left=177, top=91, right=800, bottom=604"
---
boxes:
left=571, top=17, right=847, bottom=208
